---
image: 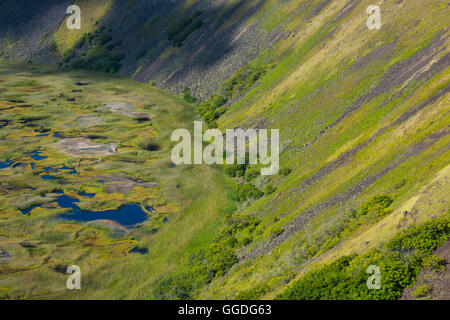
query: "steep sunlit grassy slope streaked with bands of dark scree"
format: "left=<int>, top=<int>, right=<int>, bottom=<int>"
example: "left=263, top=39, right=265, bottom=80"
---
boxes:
left=187, top=1, right=449, bottom=298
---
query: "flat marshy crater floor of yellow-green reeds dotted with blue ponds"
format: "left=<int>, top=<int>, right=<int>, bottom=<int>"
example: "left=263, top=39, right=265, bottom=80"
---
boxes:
left=0, top=64, right=231, bottom=299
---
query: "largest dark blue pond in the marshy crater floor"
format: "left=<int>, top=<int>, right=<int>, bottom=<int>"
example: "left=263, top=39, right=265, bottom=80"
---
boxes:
left=57, top=195, right=148, bottom=227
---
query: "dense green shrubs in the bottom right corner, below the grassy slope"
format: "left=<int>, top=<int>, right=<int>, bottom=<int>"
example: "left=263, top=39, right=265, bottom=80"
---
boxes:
left=277, top=216, right=450, bottom=300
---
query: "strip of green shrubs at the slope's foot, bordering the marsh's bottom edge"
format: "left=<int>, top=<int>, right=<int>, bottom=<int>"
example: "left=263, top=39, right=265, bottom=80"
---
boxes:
left=153, top=214, right=260, bottom=300
